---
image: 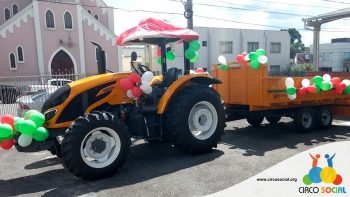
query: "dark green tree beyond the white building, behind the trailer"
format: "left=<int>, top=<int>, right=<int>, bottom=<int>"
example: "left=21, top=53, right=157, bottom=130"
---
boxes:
left=281, top=28, right=305, bottom=58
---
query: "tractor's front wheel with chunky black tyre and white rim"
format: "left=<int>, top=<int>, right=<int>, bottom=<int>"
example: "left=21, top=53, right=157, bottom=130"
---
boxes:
left=62, top=112, right=130, bottom=180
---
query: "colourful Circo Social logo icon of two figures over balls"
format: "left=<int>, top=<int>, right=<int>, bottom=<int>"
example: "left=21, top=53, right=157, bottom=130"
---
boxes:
left=303, top=153, right=343, bottom=185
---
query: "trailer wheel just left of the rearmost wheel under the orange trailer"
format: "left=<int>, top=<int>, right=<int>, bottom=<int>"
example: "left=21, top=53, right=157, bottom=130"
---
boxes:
left=294, top=107, right=315, bottom=133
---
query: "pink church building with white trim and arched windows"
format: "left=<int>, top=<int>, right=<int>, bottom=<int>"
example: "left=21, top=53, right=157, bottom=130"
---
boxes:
left=0, top=0, right=121, bottom=76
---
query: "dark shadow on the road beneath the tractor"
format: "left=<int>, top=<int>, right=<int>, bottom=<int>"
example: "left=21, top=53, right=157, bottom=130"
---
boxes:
left=0, top=144, right=223, bottom=196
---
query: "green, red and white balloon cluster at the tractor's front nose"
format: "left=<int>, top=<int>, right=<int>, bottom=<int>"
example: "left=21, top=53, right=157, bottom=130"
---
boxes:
left=0, top=110, right=49, bottom=150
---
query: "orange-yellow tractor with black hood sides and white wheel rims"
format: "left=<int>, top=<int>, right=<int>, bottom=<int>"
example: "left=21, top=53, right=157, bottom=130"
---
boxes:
left=16, top=18, right=225, bottom=180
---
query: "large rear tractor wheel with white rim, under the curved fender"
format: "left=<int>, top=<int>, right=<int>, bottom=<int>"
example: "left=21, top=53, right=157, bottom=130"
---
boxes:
left=166, top=85, right=225, bottom=154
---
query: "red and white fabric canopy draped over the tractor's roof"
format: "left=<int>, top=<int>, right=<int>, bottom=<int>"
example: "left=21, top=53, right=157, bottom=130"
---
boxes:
left=117, top=18, right=199, bottom=45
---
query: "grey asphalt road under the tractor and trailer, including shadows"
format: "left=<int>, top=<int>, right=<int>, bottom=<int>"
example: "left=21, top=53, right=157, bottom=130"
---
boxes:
left=0, top=118, right=350, bottom=197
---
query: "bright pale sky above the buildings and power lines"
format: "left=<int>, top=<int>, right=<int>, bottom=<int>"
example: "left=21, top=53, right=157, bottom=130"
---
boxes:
left=104, top=0, right=350, bottom=46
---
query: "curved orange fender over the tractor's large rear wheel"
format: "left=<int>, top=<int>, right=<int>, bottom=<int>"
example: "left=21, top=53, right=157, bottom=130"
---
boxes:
left=157, top=73, right=222, bottom=114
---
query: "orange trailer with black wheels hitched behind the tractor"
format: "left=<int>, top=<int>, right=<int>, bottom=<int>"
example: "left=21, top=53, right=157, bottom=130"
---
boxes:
left=212, top=62, right=350, bottom=132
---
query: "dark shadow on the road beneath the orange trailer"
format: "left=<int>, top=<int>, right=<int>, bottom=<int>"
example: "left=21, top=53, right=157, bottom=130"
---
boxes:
left=223, top=122, right=350, bottom=156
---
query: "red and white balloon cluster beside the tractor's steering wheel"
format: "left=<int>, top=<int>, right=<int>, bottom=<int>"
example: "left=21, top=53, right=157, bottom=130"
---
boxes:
left=119, top=71, right=153, bottom=98
